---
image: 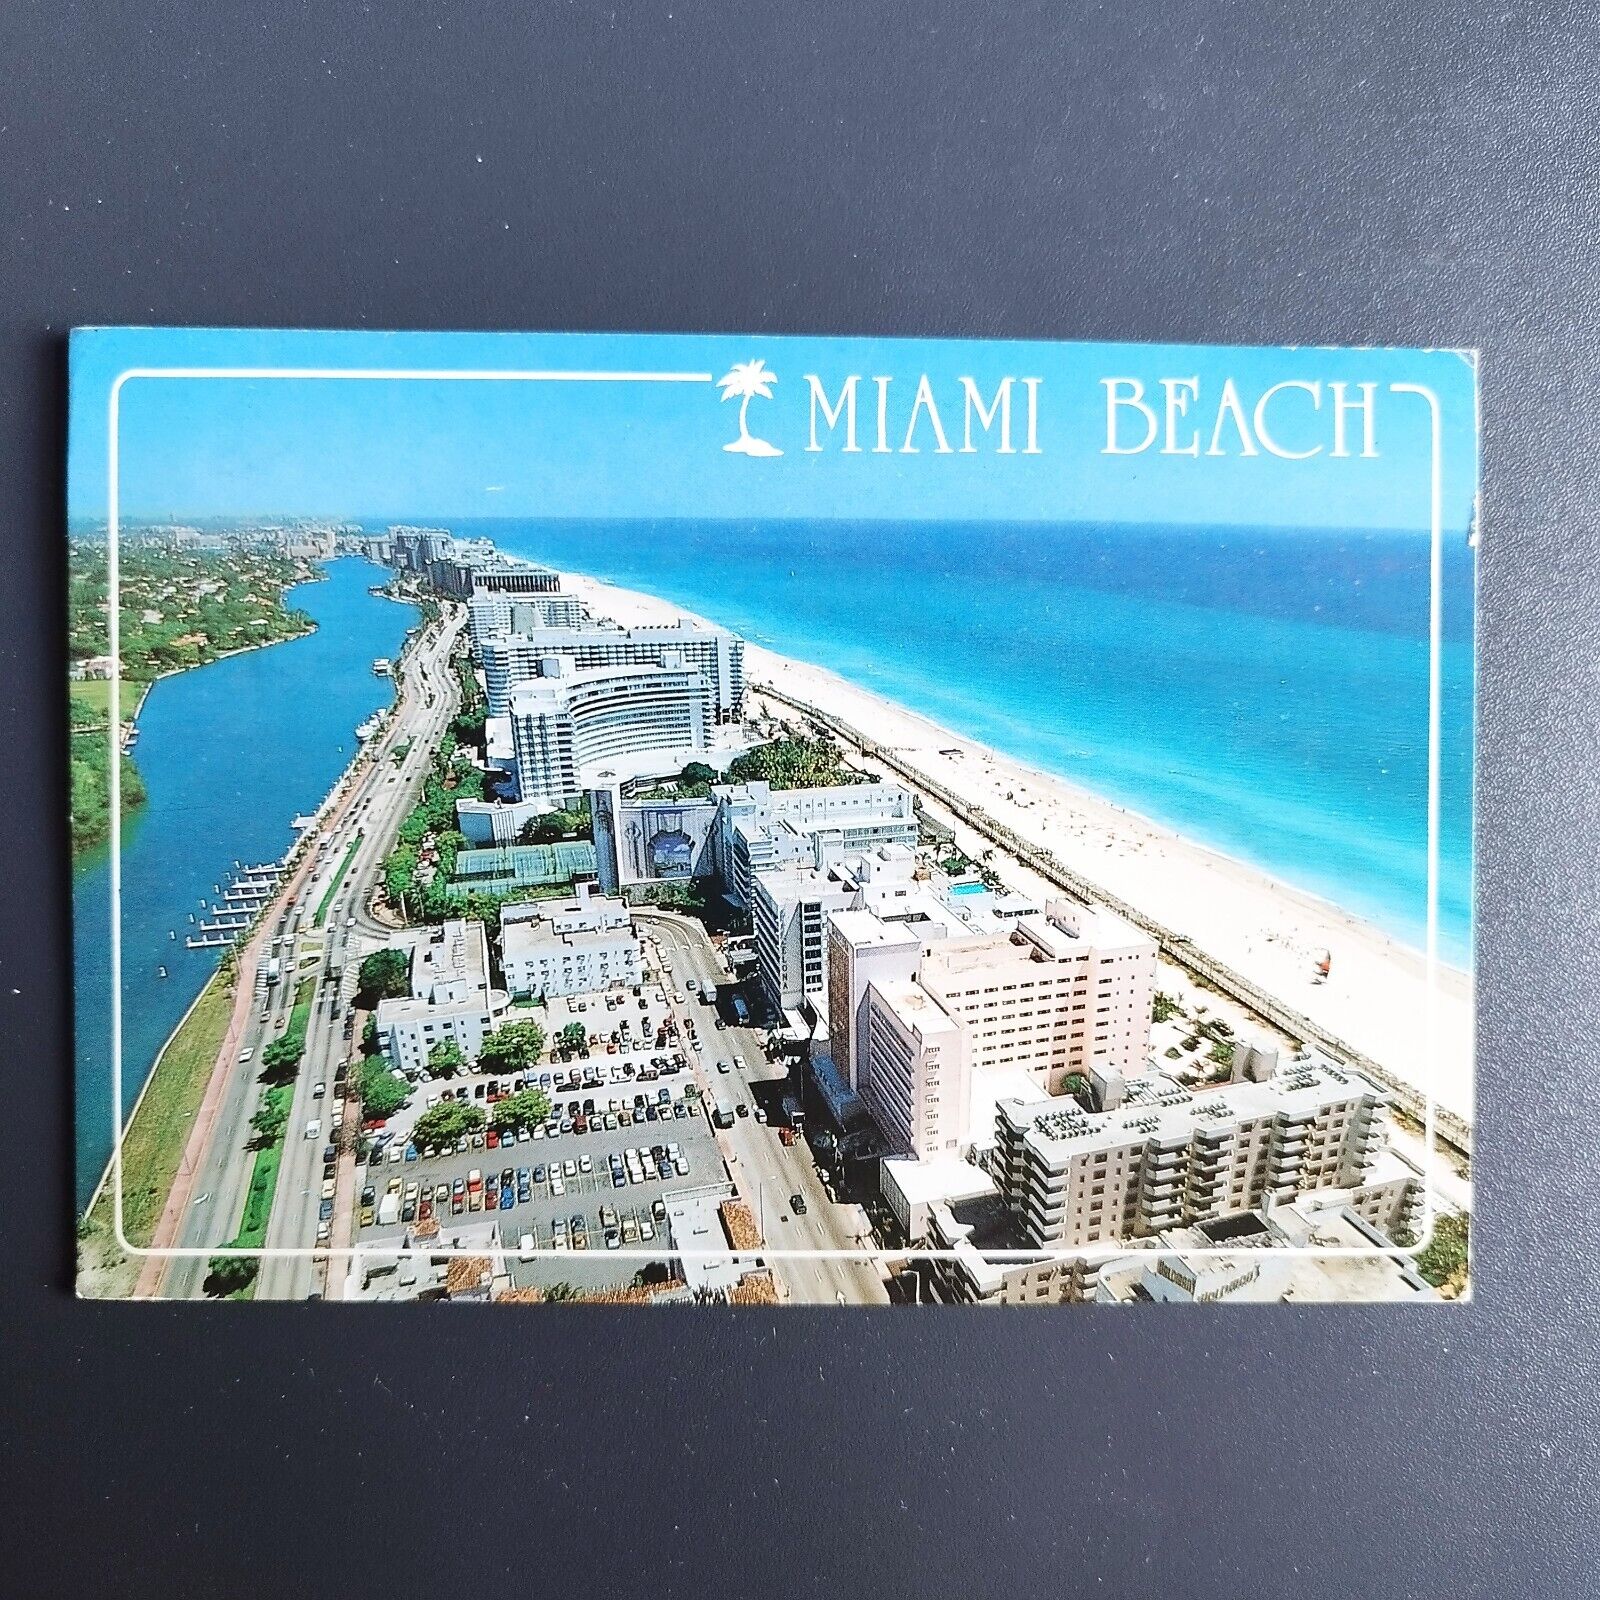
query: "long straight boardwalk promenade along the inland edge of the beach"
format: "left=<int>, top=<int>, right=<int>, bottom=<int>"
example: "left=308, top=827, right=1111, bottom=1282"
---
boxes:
left=754, top=682, right=1472, bottom=1155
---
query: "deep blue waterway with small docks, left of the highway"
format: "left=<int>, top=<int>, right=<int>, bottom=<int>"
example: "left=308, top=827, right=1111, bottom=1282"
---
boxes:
left=72, top=560, right=416, bottom=1205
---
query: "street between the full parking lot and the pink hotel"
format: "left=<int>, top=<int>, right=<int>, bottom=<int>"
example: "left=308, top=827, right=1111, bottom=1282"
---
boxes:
left=635, top=910, right=888, bottom=1306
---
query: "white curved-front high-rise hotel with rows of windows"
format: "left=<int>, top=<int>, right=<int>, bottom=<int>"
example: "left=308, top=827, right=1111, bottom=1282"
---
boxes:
left=510, top=651, right=715, bottom=810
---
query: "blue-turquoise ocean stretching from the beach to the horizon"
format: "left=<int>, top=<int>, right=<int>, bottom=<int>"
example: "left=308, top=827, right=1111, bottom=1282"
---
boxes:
left=467, top=520, right=1474, bottom=966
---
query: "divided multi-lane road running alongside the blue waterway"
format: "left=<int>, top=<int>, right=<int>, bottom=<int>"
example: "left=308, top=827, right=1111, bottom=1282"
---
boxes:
left=160, top=610, right=462, bottom=1299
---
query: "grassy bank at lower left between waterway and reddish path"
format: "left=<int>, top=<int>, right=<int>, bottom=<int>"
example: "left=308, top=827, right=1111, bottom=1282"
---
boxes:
left=78, top=971, right=234, bottom=1298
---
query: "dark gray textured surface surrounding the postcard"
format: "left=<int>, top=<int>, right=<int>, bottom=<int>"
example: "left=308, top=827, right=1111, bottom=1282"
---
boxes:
left=0, top=0, right=1600, bottom=1600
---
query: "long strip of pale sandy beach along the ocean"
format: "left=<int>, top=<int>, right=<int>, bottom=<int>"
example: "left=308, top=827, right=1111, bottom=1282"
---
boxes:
left=562, top=573, right=1474, bottom=1122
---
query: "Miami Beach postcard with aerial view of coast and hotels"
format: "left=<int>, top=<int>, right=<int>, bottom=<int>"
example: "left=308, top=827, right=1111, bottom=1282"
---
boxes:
left=67, top=328, right=1478, bottom=1315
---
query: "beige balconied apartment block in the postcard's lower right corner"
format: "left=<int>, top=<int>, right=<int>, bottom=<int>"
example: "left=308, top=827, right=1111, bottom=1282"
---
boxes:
left=994, top=1054, right=1421, bottom=1250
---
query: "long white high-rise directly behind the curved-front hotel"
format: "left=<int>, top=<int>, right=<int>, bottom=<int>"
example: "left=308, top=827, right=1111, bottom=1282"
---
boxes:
left=478, top=614, right=744, bottom=723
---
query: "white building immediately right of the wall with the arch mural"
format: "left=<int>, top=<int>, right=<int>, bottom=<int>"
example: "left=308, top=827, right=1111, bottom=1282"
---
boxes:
left=714, top=782, right=917, bottom=906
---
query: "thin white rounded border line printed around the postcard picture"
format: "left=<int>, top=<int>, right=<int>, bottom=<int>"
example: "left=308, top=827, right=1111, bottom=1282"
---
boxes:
left=106, top=366, right=1477, bottom=1266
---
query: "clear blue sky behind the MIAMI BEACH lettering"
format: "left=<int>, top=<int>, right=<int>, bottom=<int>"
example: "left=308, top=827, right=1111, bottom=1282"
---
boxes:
left=69, top=328, right=1477, bottom=531
